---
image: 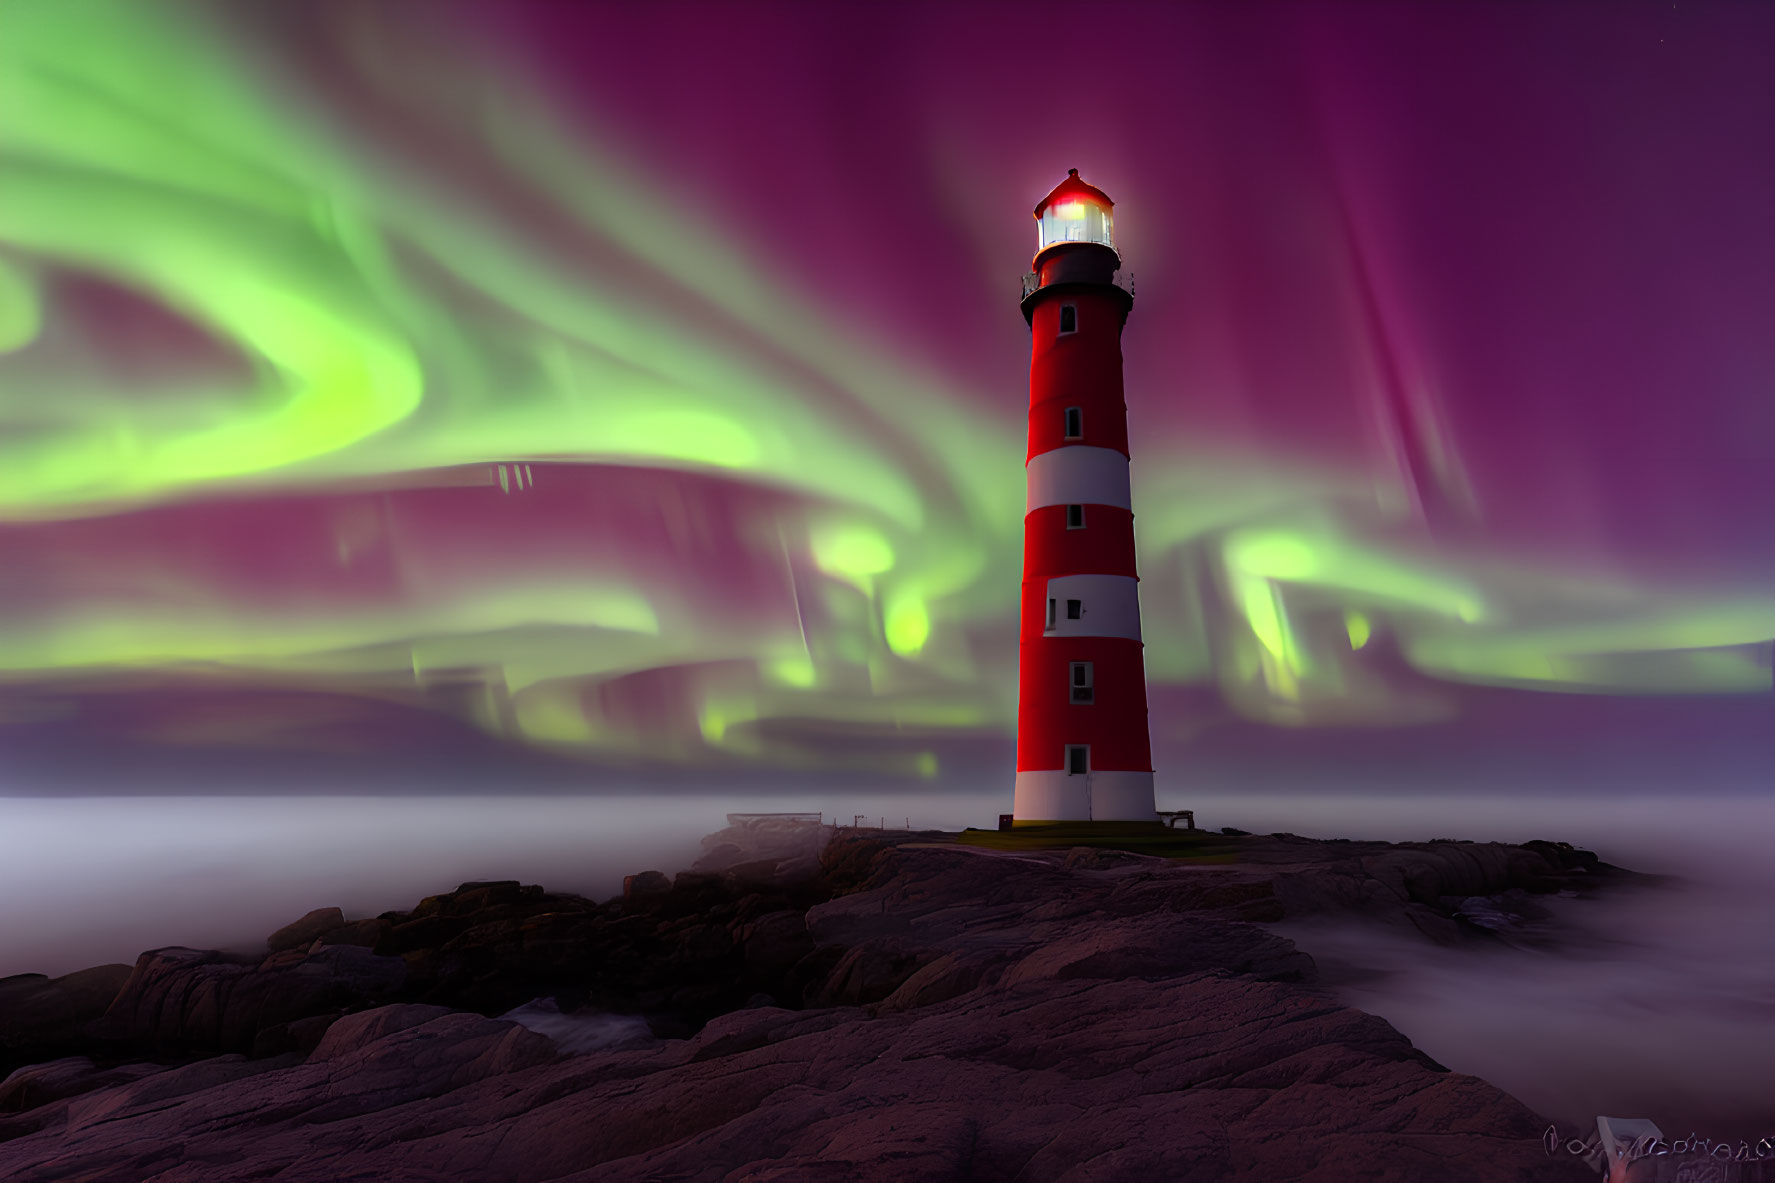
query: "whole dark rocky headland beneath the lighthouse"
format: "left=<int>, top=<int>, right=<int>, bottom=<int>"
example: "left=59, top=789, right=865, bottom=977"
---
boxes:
left=0, top=819, right=1638, bottom=1183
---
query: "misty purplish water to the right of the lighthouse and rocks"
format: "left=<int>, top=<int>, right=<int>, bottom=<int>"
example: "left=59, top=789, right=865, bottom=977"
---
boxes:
left=1227, top=796, right=1775, bottom=1142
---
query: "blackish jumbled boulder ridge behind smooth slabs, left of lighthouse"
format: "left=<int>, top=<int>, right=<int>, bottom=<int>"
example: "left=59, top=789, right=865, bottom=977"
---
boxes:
left=0, top=831, right=825, bottom=1069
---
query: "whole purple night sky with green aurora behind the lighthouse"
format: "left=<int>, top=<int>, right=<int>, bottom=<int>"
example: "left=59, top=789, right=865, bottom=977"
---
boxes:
left=0, top=0, right=1775, bottom=783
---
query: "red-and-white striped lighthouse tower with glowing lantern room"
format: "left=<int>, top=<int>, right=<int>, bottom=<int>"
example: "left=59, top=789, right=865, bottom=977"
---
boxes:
left=1012, top=169, right=1156, bottom=822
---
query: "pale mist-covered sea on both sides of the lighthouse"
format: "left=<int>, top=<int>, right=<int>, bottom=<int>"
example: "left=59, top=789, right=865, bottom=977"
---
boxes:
left=0, top=789, right=1775, bottom=1140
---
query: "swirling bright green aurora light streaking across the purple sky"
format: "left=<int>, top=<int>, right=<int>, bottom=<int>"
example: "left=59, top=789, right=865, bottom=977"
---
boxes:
left=0, top=0, right=1775, bottom=776
